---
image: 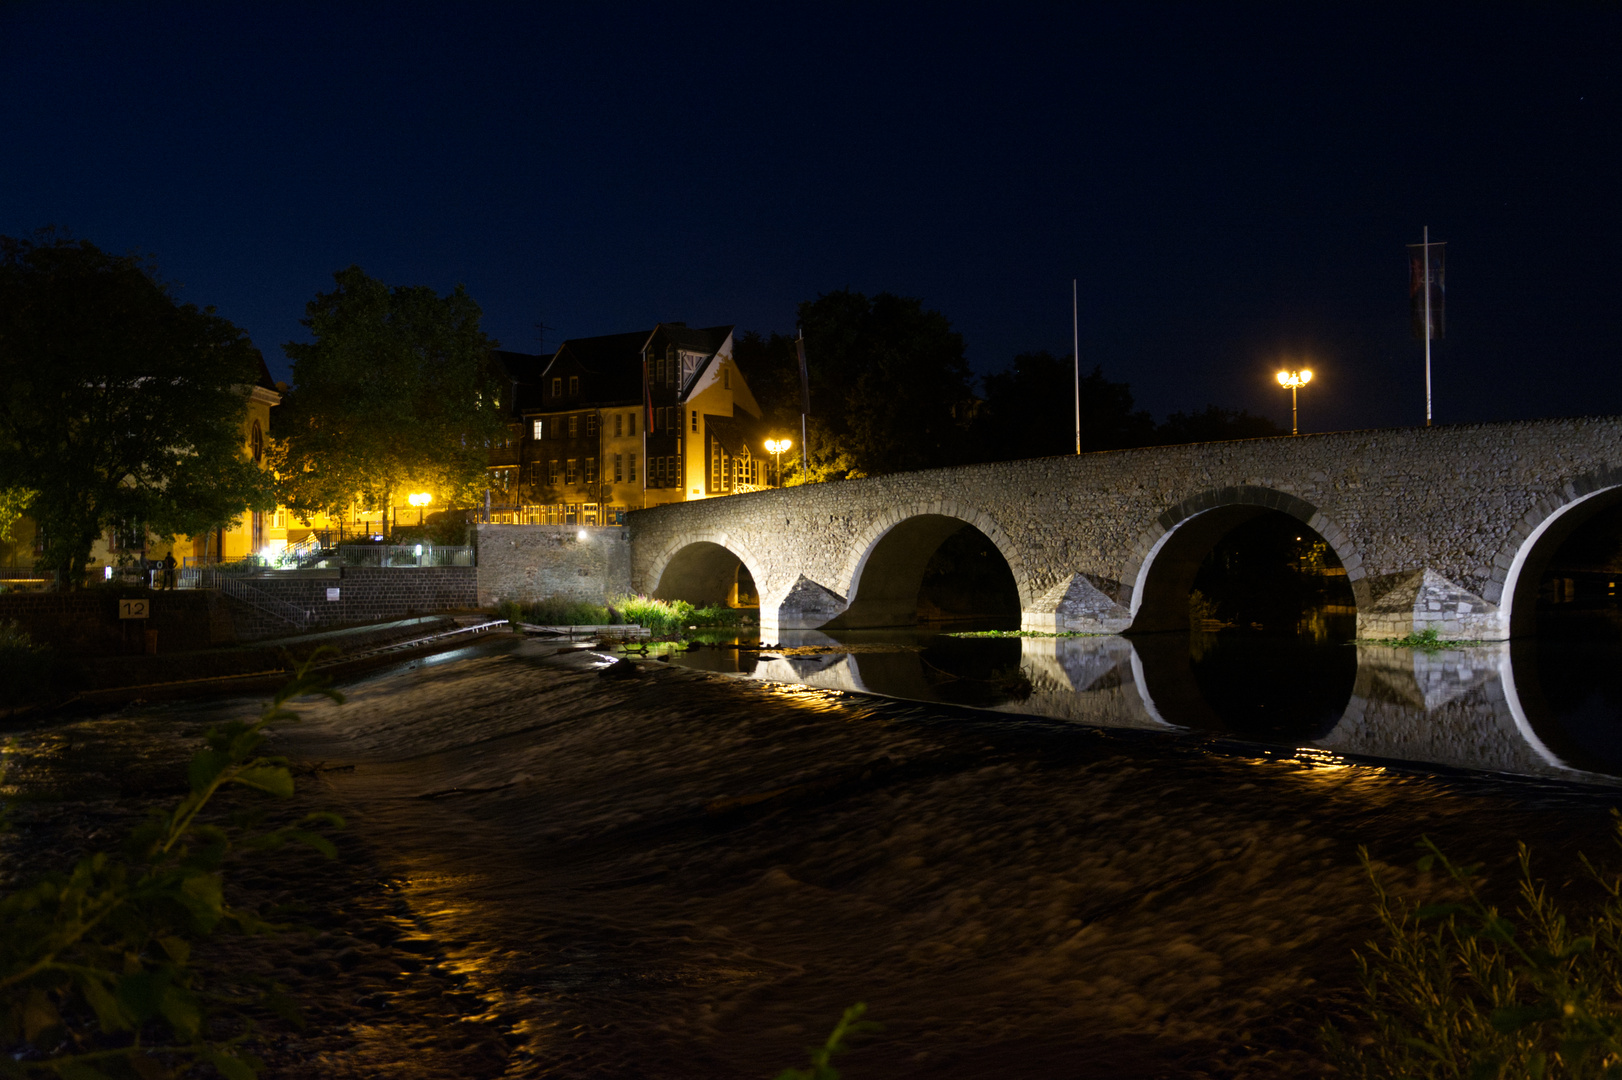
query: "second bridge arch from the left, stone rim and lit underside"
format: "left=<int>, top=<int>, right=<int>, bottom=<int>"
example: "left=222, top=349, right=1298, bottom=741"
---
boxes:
left=835, top=499, right=1032, bottom=628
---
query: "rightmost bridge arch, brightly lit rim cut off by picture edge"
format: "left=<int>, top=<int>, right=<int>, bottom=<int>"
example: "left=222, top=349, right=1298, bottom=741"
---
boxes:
left=1483, top=467, right=1622, bottom=637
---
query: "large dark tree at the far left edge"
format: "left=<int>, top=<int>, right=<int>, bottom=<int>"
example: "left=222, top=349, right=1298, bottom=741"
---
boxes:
left=0, top=230, right=276, bottom=587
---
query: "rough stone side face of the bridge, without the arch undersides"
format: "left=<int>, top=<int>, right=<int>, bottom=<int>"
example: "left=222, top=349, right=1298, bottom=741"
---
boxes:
left=628, top=417, right=1622, bottom=636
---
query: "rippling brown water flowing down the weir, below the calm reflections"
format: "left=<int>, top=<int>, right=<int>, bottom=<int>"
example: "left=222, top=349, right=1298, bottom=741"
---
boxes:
left=5, top=641, right=1616, bottom=1080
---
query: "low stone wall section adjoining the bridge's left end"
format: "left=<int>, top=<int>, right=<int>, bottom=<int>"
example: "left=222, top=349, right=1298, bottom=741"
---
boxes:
left=475, top=525, right=631, bottom=606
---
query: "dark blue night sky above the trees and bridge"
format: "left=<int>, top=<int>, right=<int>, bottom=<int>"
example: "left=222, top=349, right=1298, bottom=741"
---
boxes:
left=0, top=2, right=1622, bottom=430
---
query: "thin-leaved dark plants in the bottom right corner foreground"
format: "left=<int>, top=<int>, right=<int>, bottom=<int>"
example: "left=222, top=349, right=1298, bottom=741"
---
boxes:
left=1324, top=819, right=1622, bottom=1080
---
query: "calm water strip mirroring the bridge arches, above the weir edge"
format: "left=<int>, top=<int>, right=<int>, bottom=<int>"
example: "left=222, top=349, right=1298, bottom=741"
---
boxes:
left=658, top=628, right=1622, bottom=782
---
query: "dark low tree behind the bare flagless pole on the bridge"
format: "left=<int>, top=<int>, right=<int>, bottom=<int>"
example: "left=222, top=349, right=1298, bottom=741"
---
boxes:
left=975, top=352, right=1155, bottom=461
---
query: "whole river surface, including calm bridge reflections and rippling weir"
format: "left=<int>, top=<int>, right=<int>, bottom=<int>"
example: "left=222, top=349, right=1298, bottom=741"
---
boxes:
left=240, top=631, right=1616, bottom=1080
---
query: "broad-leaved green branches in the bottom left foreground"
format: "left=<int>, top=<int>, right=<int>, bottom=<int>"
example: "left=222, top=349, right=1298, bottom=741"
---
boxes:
left=0, top=657, right=344, bottom=1080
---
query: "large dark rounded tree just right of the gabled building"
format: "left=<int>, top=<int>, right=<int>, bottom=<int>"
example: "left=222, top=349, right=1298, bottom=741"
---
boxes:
left=735, top=290, right=973, bottom=483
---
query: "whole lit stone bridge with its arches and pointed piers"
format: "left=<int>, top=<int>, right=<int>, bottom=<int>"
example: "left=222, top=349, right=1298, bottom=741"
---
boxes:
left=629, top=417, right=1622, bottom=641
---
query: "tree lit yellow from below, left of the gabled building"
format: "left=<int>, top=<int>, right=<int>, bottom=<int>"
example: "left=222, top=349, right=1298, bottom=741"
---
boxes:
left=271, top=266, right=506, bottom=521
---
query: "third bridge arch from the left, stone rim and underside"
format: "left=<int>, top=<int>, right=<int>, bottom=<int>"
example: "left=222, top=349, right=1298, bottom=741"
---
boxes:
left=1121, top=485, right=1369, bottom=632
